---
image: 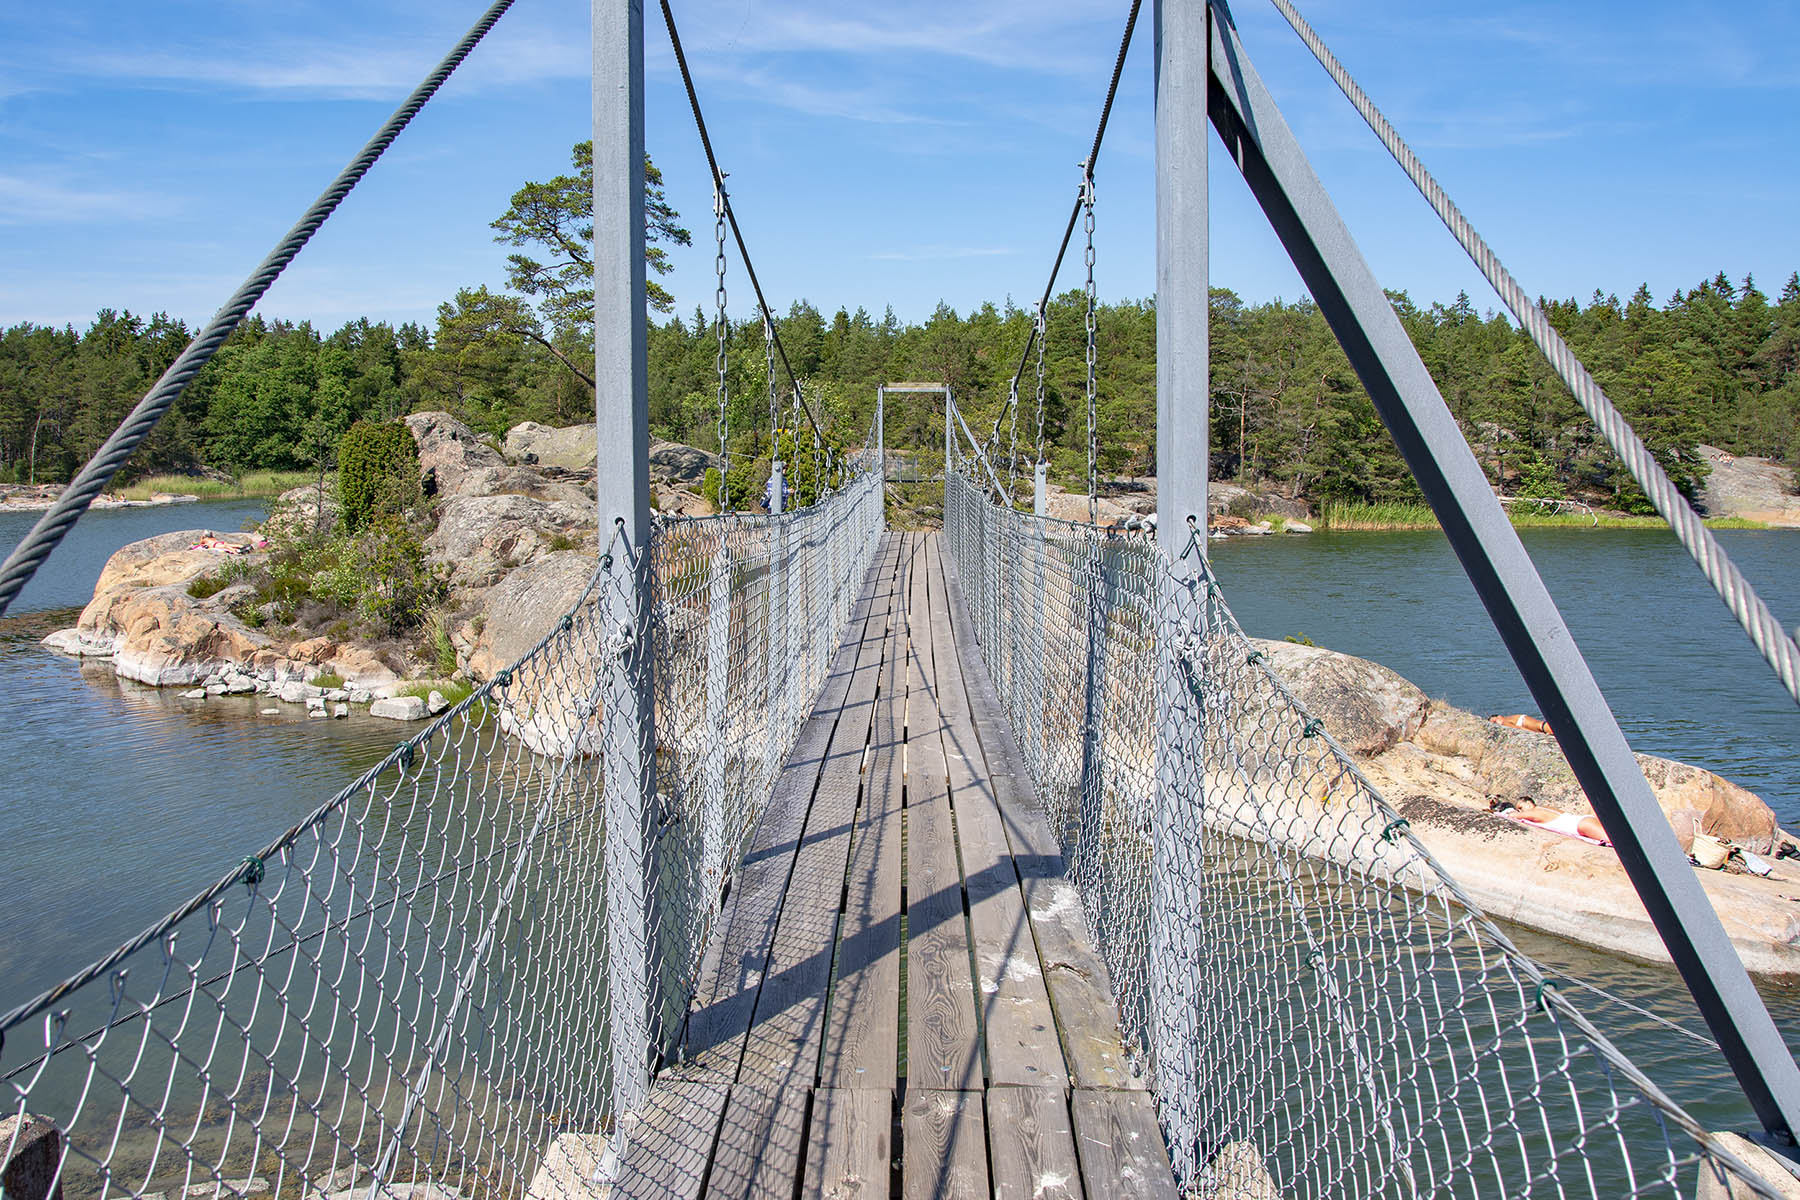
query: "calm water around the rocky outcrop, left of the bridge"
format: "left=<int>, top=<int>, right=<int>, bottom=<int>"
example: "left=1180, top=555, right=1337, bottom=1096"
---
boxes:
left=0, top=500, right=400, bottom=1011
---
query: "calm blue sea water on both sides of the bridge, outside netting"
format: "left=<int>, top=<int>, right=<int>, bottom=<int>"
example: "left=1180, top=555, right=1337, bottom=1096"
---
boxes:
left=0, top=504, right=1800, bottom=1128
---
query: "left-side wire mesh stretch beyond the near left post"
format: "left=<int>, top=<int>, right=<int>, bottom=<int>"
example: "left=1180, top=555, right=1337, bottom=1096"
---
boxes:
left=650, top=471, right=882, bottom=1040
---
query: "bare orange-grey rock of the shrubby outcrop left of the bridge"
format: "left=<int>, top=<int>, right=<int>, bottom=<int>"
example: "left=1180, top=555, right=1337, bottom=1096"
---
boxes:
left=45, top=412, right=718, bottom=720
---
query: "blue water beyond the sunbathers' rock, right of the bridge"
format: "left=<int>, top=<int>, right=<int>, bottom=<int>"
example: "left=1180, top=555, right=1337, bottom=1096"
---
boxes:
left=1211, top=529, right=1800, bottom=828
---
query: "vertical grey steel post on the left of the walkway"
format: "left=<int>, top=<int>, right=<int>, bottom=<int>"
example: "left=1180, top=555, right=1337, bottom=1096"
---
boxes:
left=592, top=0, right=662, bottom=1151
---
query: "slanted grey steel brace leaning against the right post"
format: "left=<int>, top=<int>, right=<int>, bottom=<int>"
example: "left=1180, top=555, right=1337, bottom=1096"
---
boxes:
left=1210, top=4, right=1800, bottom=1146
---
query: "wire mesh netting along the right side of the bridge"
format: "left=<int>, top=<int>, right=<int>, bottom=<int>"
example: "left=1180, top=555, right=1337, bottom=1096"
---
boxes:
left=945, top=471, right=1778, bottom=1200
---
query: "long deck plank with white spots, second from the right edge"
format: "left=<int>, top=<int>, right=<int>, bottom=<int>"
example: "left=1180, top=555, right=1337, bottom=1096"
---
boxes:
left=931, top=540, right=1069, bottom=1087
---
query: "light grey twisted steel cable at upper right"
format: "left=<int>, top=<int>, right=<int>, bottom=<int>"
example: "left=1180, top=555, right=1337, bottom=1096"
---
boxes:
left=1273, top=0, right=1800, bottom=703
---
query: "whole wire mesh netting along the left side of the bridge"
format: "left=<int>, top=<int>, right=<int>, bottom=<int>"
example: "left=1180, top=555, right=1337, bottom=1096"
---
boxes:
left=0, top=471, right=882, bottom=1200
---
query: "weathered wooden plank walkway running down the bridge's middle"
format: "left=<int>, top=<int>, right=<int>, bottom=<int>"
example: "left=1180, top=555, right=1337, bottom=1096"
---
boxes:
left=614, top=534, right=1175, bottom=1200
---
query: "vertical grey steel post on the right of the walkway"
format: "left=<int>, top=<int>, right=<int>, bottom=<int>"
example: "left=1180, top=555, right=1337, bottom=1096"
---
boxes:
left=1148, top=0, right=1211, bottom=1178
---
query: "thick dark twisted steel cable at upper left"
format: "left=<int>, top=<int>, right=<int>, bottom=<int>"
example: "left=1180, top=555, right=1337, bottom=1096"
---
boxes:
left=0, top=0, right=513, bottom=615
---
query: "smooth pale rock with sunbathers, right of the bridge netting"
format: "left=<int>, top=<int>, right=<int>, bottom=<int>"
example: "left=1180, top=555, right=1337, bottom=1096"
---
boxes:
left=1253, top=639, right=1800, bottom=979
